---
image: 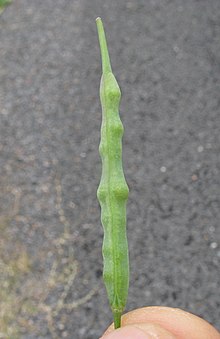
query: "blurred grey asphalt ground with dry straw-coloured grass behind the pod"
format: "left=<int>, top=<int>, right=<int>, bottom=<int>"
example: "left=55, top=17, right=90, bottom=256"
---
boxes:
left=0, top=0, right=220, bottom=339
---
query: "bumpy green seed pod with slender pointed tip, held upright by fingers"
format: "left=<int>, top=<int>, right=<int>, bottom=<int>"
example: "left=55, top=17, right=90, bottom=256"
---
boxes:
left=96, top=18, right=129, bottom=328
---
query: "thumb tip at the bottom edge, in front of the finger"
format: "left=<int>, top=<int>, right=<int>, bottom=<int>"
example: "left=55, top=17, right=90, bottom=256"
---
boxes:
left=100, top=323, right=177, bottom=339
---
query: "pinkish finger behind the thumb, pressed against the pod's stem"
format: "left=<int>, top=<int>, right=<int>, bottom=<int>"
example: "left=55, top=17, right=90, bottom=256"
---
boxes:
left=102, top=306, right=220, bottom=339
